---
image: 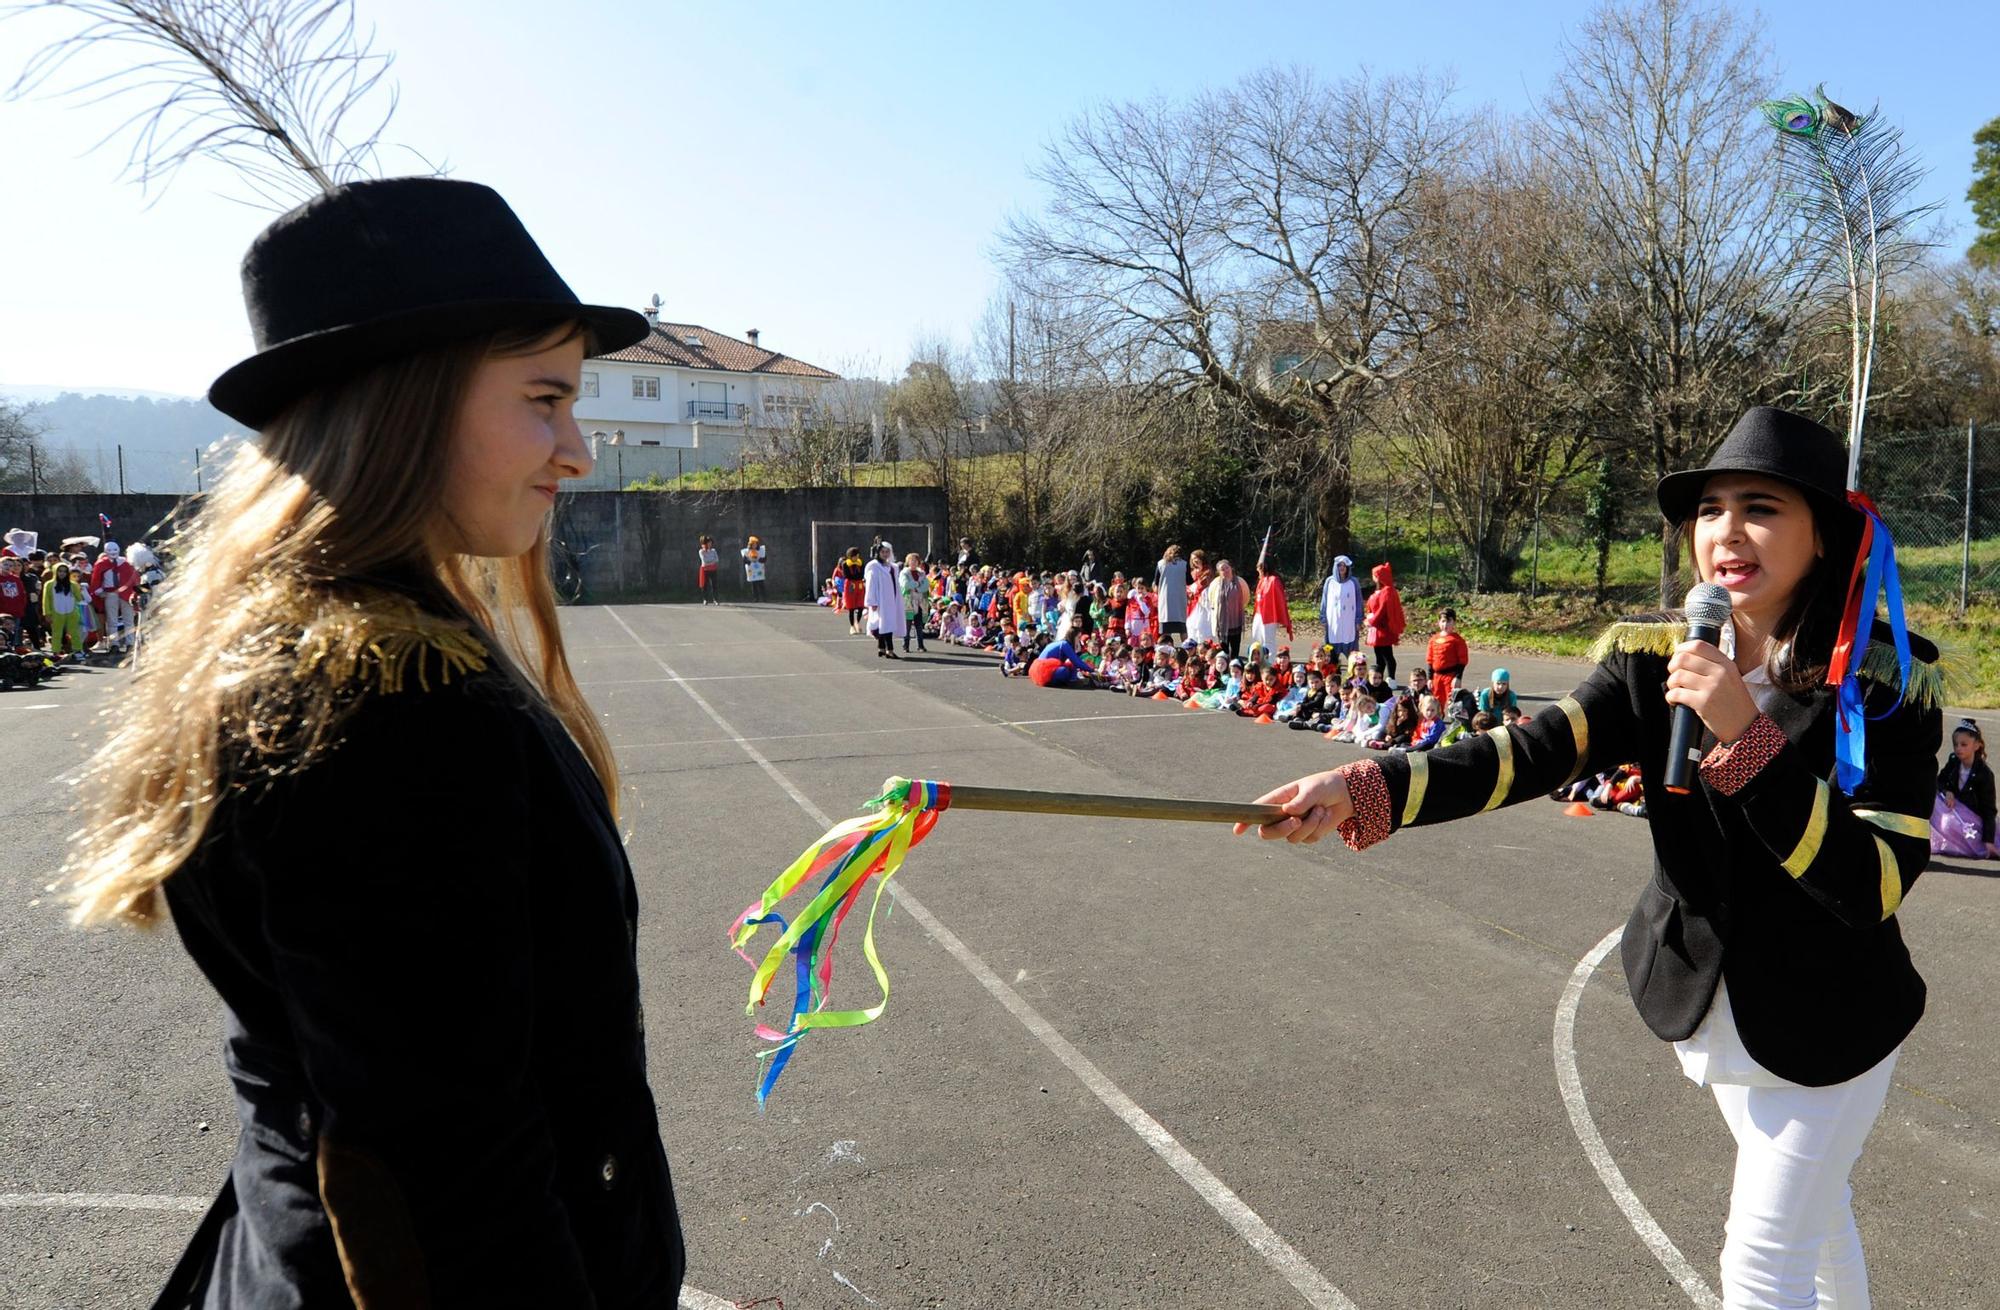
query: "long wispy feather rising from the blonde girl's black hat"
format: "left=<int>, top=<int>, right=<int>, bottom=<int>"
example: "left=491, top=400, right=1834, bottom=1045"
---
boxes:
left=0, top=0, right=422, bottom=208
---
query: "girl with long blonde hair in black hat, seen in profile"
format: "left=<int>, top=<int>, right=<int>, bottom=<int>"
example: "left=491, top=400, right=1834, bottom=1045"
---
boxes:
left=70, top=178, right=684, bottom=1310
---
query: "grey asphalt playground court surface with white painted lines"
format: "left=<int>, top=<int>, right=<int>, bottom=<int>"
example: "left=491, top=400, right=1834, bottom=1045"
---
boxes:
left=0, top=606, right=2000, bottom=1310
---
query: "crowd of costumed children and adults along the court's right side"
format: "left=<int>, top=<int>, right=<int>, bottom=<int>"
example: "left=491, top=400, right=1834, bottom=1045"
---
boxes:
left=820, top=542, right=1688, bottom=816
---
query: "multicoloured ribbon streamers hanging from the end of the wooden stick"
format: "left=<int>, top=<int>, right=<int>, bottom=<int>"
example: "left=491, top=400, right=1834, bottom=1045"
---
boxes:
left=730, top=778, right=952, bottom=1108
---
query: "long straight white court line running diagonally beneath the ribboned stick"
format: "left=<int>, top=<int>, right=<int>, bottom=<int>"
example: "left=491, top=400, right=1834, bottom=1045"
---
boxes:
left=604, top=608, right=1356, bottom=1310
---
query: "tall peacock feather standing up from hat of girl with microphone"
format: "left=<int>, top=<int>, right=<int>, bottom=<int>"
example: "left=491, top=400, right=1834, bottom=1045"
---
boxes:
left=1762, top=84, right=1936, bottom=488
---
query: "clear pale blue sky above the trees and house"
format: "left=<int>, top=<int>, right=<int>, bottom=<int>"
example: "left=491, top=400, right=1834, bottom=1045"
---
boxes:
left=0, top=0, right=2000, bottom=394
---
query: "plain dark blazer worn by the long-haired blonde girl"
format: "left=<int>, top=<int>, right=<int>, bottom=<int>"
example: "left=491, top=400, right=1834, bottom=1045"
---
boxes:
left=160, top=672, right=684, bottom=1310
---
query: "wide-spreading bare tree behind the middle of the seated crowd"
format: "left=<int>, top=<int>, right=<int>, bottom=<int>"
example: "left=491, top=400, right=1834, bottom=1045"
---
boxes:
left=1002, top=70, right=1456, bottom=558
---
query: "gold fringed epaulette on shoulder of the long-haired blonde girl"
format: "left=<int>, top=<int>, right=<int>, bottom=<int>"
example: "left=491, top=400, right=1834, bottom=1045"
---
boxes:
left=292, top=592, right=486, bottom=696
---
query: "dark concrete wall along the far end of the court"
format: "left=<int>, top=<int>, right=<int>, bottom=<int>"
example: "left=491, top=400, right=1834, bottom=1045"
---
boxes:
left=0, top=486, right=956, bottom=602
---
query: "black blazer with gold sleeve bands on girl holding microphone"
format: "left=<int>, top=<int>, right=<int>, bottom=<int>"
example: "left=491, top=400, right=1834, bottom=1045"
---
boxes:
left=1350, top=614, right=1940, bottom=1086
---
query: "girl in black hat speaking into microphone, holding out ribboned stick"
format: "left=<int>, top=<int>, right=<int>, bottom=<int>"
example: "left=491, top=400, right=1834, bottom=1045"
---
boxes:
left=1238, top=408, right=1940, bottom=1310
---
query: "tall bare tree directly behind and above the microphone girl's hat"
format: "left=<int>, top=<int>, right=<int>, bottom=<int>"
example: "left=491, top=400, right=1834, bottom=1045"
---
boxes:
left=1538, top=0, right=1800, bottom=604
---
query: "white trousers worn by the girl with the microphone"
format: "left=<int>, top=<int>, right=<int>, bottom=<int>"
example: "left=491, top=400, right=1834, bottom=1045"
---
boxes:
left=1712, top=1048, right=1900, bottom=1310
